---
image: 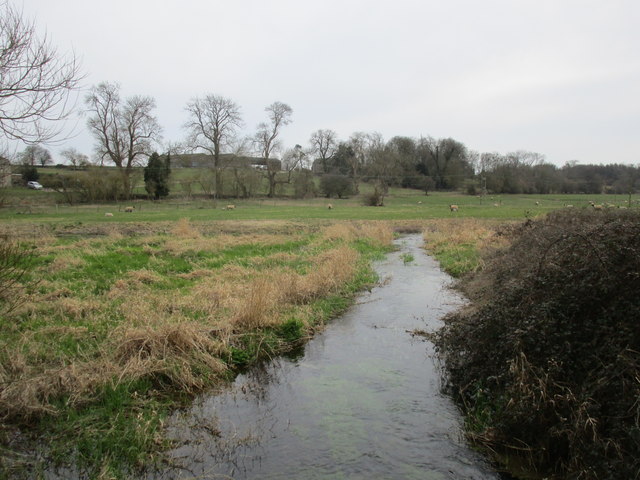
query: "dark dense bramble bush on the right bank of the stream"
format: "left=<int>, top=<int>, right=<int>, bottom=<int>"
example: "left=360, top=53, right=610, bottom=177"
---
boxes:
left=437, top=211, right=640, bottom=480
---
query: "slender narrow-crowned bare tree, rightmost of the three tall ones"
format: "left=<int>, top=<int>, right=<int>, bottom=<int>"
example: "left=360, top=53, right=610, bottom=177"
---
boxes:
left=254, top=102, right=293, bottom=197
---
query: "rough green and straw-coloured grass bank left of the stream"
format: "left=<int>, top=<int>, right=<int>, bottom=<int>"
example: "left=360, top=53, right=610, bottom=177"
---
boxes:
left=0, top=220, right=392, bottom=478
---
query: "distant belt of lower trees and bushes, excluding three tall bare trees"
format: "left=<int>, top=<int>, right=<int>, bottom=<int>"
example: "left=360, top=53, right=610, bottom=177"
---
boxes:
left=13, top=130, right=640, bottom=205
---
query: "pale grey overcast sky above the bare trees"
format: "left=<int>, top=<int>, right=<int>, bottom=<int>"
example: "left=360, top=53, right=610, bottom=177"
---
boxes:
left=14, top=0, right=640, bottom=165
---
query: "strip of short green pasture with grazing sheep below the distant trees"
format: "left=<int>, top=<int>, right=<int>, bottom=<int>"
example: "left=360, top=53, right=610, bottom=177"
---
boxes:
left=0, top=187, right=640, bottom=229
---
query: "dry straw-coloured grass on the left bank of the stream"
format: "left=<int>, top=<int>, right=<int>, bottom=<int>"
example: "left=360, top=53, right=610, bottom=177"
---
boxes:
left=0, top=220, right=380, bottom=432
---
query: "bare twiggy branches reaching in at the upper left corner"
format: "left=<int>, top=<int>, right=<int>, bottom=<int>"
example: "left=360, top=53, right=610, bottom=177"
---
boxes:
left=0, top=1, right=82, bottom=144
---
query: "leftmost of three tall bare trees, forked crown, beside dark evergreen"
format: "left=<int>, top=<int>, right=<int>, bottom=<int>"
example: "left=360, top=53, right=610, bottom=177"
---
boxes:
left=85, top=83, right=162, bottom=197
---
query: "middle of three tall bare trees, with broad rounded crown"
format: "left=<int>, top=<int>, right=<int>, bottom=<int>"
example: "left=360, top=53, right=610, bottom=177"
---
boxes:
left=185, top=95, right=243, bottom=198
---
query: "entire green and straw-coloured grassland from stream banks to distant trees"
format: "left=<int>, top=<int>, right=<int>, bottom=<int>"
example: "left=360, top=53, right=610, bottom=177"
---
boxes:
left=0, top=190, right=635, bottom=478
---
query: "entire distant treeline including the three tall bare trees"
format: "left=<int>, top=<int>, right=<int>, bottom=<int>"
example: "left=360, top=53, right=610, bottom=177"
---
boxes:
left=10, top=83, right=640, bottom=205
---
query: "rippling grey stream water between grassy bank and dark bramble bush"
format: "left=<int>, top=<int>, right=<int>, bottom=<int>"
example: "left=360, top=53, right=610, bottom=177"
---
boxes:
left=153, top=235, right=500, bottom=480
